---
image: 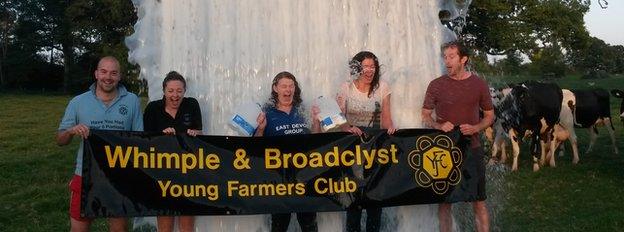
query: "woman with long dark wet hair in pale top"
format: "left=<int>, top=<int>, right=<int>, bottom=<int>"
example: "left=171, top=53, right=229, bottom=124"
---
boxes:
left=336, top=51, right=396, bottom=231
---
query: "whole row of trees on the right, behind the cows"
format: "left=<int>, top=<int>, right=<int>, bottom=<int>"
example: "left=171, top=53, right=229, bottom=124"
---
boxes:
left=462, top=0, right=624, bottom=78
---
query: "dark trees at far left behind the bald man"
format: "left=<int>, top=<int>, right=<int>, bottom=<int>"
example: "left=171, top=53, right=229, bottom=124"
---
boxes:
left=0, top=0, right=136, bottom=92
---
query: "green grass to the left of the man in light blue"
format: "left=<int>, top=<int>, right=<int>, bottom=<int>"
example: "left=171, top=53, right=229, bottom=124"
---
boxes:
left=0, top=94, right=105, bottom=231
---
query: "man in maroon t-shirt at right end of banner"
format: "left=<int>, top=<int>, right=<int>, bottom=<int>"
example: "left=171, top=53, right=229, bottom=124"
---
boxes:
left=422, top=42, right=494, bottom=232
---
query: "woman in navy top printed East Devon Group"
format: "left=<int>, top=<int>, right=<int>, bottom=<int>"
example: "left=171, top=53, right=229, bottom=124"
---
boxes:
left=254, top=72, right=321, bottom=232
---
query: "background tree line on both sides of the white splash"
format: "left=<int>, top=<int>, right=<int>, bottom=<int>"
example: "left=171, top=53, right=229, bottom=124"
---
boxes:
left=0, top=0, right=624, bottom=93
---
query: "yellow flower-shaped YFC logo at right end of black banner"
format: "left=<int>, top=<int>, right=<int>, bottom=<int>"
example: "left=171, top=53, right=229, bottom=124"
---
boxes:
left=407, top=135, right=462, bottom=195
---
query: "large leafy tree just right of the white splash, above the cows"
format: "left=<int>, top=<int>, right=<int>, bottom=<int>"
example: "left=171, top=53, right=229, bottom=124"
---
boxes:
left=463, top=0, right=590, bottom=55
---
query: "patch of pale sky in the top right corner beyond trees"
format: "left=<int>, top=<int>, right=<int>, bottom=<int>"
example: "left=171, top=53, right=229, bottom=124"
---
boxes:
left=585, top=0, right=624, bottom=45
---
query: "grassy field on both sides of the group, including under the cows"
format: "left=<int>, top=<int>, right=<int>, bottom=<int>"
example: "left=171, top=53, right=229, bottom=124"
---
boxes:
left=0, top=76, right=624, bottom=231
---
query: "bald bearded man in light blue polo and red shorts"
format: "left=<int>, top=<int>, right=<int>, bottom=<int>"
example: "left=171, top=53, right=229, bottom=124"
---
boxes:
left=56, top=56, right=143, bottom=231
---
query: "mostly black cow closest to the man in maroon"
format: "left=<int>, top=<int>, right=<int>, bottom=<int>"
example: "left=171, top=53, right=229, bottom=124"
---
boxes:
left=495, top=81, right=563, bottom=170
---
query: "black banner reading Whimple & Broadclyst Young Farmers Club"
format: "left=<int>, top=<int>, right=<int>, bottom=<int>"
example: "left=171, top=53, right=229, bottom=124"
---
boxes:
left=81, top=129, right=485, bottom=217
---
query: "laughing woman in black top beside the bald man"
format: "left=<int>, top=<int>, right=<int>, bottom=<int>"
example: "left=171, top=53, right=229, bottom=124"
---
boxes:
left=143, top=71, right=202, bottom=232
